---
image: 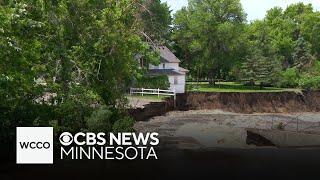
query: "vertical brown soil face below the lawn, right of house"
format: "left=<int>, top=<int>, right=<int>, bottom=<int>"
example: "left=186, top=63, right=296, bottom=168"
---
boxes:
left=171, top=91, right=320, bottom=113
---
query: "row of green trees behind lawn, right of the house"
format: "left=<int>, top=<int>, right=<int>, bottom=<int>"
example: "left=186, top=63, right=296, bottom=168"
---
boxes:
left=172, top=0, right=320, bottom=89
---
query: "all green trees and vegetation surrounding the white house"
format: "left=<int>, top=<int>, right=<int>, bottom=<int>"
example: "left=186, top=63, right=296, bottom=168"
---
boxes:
left=0, top=0, right=320, bottom=142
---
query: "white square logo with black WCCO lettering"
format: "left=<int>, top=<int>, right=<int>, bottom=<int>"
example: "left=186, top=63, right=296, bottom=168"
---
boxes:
left=16, top=127, right=53, bottom=164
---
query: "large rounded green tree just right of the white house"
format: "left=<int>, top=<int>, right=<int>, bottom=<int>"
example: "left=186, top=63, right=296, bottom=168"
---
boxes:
left=173, top=0, right=247, bottom=79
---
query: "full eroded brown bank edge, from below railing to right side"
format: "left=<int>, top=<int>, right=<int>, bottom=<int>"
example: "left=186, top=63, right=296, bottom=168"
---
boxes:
left=129, top=91, right=320, bottom=121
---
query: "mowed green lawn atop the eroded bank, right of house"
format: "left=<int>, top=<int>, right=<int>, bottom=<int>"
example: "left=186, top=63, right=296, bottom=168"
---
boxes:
left=187, top=82, right=301, bottom=92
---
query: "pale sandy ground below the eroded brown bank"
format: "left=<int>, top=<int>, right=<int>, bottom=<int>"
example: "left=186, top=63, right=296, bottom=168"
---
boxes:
left=135, top=110, right=320, bottom=148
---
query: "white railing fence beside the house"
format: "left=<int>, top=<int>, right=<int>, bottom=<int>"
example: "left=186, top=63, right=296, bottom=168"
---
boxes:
left=130, top=88, right=176, bottom=104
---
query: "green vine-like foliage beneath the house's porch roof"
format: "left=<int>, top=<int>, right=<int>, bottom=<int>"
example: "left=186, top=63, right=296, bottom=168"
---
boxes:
left=135, top=75, right=170, bottom=89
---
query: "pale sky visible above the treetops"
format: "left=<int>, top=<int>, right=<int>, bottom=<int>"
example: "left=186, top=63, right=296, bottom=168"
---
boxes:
left=161, top=0, right=320, bottom=21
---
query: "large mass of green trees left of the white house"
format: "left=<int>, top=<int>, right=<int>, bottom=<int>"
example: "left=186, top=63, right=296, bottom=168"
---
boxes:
left=0, top=0, right=155, bottom=143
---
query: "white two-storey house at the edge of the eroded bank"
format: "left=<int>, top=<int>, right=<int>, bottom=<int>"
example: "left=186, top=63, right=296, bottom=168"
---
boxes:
left=149, top=46, right=189, bottom=93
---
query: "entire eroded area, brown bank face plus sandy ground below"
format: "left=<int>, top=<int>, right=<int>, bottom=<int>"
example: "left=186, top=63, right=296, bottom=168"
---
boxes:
left=130, top=91, right=320, bottom=149
